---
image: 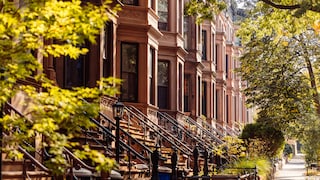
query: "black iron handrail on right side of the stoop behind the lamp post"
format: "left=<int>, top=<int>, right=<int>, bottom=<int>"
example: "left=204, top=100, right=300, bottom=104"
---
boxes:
left=125, top=106, right=192, bottom=155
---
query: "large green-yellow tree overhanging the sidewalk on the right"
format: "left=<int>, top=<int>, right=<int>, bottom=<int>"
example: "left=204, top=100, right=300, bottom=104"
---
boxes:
left=238, top=0, right=320, bottom=161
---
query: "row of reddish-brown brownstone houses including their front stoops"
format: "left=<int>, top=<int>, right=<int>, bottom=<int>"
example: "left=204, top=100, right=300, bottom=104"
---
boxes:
left=3, top=0, right=252, bottom=180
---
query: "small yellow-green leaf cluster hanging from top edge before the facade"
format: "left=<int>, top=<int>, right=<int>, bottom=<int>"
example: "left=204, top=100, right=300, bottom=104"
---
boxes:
left=185, top=0, right=226, bottom=23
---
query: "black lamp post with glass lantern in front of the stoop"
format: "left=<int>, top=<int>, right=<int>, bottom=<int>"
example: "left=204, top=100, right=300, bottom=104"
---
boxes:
left=112, top=101, right=124, bottom=164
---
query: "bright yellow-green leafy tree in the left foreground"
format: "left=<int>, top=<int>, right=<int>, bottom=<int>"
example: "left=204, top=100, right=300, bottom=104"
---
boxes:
left=0, top=0, right=119, bottom=173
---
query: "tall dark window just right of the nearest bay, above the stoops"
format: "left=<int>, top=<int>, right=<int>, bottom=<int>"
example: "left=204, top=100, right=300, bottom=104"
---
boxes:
left=158, top=61, right=169, bottom=109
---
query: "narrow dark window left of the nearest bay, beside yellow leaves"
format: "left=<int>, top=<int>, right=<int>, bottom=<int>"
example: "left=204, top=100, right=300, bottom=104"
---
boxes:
left=103, top=23, right=113, bottom=77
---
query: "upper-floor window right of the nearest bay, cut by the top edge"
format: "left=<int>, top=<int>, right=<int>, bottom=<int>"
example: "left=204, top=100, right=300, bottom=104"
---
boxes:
left=158, top=0, right=168, bottom=31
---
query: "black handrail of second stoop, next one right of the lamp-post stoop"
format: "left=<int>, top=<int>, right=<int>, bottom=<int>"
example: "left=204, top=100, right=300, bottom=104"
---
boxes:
left=158, top=112, right=212, bottom=151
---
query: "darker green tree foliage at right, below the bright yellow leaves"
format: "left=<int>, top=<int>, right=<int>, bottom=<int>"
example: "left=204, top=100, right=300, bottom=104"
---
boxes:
left=239, top=22, right=319, bottom=134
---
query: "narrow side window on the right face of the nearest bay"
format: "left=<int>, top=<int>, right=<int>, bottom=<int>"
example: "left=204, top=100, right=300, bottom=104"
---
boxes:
left=148, top=47, right=155, bottom=105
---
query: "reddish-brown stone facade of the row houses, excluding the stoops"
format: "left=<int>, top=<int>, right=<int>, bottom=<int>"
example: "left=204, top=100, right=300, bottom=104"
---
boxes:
left=44, top=0, right=252, bottom=138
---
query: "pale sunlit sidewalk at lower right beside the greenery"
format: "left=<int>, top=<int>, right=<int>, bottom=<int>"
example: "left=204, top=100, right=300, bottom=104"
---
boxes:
left=275, top=154, right=320, bottom=180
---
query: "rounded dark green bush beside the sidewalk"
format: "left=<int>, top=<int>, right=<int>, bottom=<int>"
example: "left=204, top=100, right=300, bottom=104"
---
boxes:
left=240, top=122, right=285, bottom=158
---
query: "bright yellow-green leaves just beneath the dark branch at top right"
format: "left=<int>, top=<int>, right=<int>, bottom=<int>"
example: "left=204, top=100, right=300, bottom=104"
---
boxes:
left=239, top=2, right=320, bottom=44
